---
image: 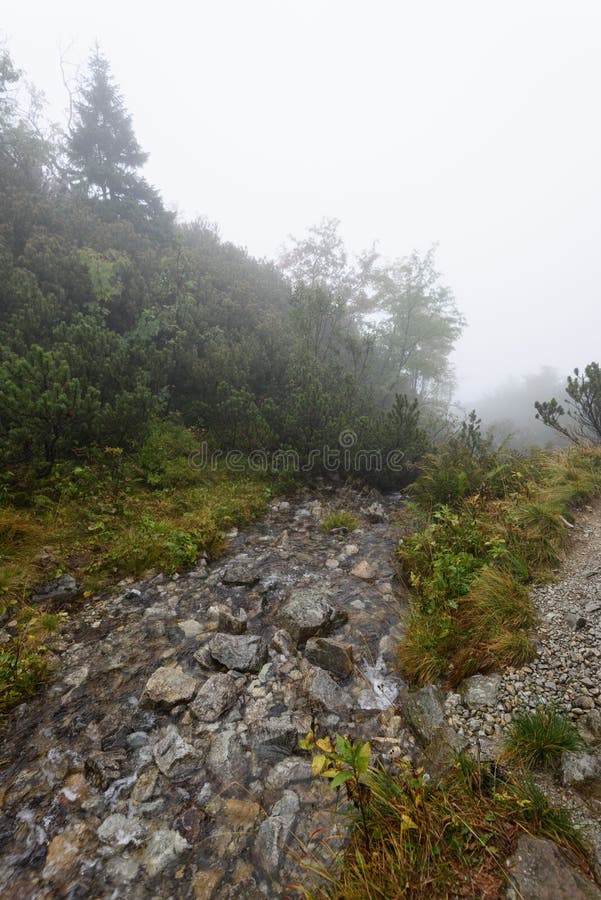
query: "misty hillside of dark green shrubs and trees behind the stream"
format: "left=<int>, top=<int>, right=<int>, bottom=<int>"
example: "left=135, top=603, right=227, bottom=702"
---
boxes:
left=0, top=48, right=584, bottom=482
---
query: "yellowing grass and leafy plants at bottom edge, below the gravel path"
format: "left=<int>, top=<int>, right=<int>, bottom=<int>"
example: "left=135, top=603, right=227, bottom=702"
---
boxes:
left=304, top=736, right=590, bottom=900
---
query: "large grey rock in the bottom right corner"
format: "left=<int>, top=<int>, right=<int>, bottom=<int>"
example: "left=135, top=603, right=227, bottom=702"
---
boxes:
left=507, top=835, right=601, bottom=900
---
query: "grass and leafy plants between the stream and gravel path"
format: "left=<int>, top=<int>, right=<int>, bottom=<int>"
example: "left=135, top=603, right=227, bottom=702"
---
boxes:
left=399, top=432, right=601, bottom=685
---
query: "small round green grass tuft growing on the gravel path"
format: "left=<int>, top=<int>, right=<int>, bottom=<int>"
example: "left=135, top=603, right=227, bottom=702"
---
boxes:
left=504, top=706, right=584, bottom=769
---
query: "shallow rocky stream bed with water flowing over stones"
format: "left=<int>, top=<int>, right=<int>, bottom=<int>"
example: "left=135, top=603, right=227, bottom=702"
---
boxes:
left=0, top=490, right=415, bottom=900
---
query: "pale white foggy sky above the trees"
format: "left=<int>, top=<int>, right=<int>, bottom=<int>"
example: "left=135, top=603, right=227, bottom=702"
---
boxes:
left=0, top=0, right=601, bottom=400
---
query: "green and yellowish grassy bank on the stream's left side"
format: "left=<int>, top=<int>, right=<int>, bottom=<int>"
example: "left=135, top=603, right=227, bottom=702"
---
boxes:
left=0, top=426, right=280, bottom=713
